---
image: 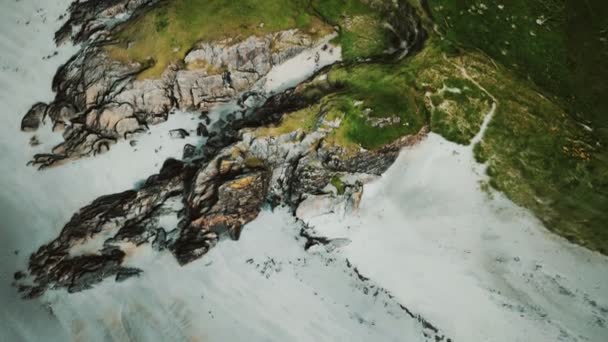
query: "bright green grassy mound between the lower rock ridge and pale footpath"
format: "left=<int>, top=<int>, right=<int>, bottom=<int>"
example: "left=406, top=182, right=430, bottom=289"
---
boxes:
left=261, top=41, right=491, bottom=150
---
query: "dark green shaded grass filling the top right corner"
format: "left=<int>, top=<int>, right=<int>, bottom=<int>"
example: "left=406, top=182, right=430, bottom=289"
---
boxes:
left=429, top=0, right=608, bottom=129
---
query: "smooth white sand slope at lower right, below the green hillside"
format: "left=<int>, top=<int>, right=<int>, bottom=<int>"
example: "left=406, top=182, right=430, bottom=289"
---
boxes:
left=309, top=134, right=608, bottom=342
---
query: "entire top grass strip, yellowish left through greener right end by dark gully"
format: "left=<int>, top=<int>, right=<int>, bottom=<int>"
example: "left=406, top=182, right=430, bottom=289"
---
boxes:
left=107, top=0, right=404, bottom=78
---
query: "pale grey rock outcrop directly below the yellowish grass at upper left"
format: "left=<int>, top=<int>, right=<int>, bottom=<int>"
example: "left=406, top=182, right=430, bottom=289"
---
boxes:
left=22, top=18, right=328, bottom=168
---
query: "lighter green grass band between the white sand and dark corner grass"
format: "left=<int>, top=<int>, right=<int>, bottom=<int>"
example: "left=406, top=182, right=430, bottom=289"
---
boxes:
left=473, top=52, right=608, bottom=253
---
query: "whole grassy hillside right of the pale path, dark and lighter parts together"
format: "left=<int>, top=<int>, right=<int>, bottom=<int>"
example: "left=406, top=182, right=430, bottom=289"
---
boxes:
left=429, top=0, right=608, bottom=253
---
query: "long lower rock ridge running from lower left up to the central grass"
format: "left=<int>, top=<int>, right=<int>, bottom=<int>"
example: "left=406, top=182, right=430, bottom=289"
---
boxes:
left=21, top=79, right=426, bottom=297
